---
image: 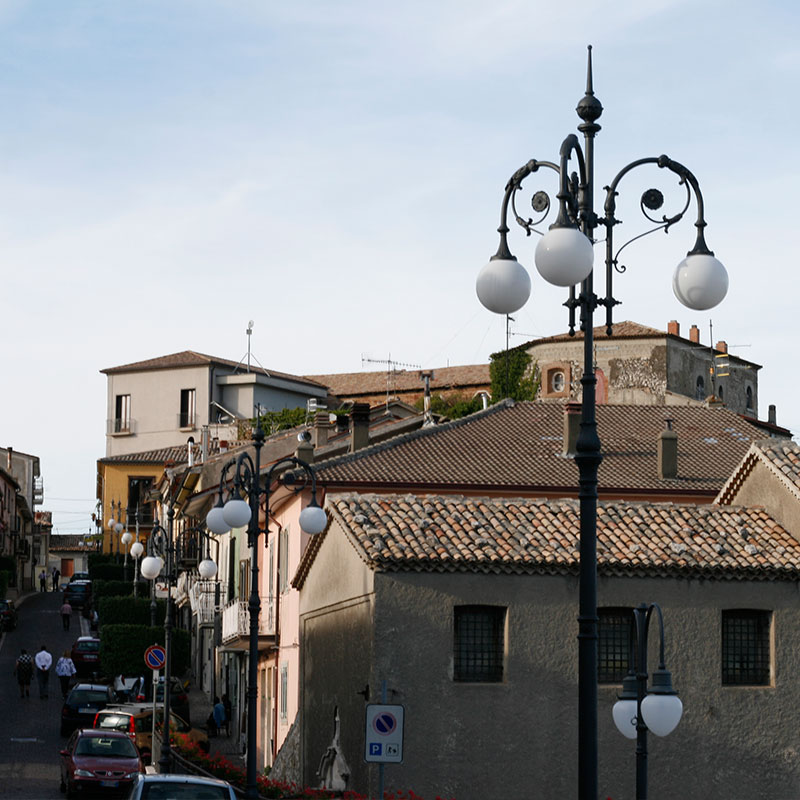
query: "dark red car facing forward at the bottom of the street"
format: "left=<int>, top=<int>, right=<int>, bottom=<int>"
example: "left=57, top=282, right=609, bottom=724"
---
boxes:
left=60, top=730, right=144, bottom=797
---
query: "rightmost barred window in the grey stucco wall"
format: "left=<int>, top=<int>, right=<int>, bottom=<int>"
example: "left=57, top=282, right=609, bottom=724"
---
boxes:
left=722, top=609, right=772, bottom=686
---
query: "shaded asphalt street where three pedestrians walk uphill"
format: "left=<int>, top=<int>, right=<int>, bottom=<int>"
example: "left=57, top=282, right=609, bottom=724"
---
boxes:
left=0, top=592, right=87, bottom=800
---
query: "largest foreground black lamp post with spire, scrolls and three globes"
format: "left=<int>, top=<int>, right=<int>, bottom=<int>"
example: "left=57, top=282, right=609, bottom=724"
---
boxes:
left=476, top=47, right=728, bottom=800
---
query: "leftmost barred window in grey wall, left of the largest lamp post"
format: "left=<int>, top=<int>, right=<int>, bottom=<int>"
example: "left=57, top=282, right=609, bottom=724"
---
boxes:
left=453, top=606, right=506, bottom=683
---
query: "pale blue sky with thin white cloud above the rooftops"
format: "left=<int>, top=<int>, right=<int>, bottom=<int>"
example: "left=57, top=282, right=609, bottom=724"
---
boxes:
left=0, top=0, right=800, bottom=533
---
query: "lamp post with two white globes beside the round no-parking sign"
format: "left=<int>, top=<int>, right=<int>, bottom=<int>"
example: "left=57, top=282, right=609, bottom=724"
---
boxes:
left=137, top=503, right=217, bottom=773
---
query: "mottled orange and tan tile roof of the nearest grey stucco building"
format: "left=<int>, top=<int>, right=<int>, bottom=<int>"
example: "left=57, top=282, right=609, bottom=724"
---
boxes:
left=295, top=494, right=800, bottom=585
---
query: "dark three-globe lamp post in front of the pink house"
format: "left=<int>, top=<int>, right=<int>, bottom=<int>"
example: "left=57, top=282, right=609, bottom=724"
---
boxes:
left=206, top=420, right=328, bottom=800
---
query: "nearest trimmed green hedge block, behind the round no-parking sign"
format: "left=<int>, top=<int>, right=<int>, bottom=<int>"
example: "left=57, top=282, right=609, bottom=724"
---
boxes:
left=100, top=624, right=190, bottom=676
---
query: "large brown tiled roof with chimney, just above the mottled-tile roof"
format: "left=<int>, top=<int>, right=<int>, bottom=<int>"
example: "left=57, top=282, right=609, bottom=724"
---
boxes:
left=310, top=400, right=763, bottom=500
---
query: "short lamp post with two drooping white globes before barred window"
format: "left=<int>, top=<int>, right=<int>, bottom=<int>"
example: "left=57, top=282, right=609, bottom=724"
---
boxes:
left=612, top=603, right=683, bottom=800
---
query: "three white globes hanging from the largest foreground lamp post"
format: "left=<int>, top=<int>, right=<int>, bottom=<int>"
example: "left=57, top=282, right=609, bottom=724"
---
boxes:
left=475, top=225, right=728, bottom=314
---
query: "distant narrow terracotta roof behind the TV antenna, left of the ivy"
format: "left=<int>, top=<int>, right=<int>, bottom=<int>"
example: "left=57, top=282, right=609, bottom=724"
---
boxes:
left=305, top=364, right=491, bottom=397
